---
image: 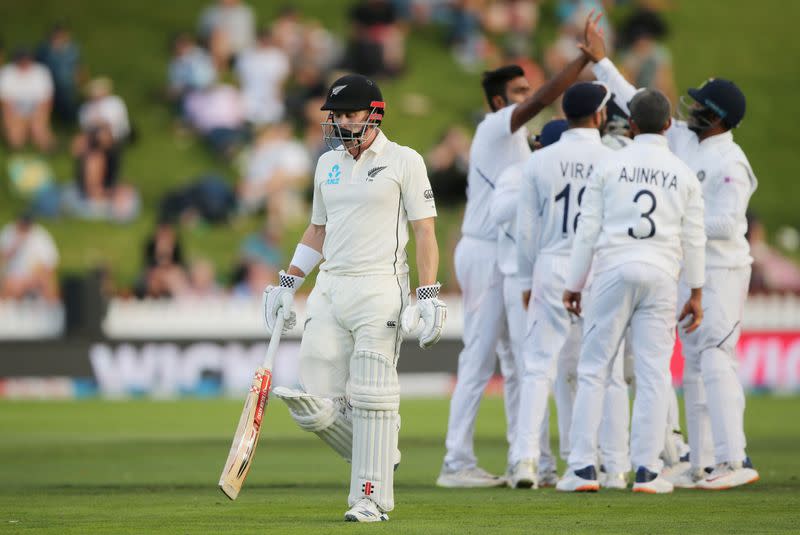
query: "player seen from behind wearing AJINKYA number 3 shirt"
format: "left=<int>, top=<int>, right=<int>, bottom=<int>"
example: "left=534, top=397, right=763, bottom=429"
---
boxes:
left=557, top=90, right=705, bottom=493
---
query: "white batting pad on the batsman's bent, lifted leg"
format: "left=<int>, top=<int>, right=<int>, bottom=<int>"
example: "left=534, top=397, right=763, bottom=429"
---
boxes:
left=272, top=386, right=353, bottom=462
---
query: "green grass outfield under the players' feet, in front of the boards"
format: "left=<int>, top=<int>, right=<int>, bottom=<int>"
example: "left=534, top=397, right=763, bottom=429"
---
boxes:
left=0, top=397, right=800, bottom=534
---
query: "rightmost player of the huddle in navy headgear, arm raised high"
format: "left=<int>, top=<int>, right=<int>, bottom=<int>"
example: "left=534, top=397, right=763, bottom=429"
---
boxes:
left=584, top=38, right=759, bottom=490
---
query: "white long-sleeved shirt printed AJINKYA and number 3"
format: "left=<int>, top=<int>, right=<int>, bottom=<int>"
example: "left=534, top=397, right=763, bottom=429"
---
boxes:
left=567, top=134, right=706, bottom=291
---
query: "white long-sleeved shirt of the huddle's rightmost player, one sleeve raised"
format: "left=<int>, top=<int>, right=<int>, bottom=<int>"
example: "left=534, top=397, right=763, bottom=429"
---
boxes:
left=592, top=58, right=758, bottom=268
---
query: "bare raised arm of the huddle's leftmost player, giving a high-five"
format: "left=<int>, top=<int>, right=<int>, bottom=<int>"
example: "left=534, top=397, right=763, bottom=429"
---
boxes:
left=511, top=10, right=603, bottom=132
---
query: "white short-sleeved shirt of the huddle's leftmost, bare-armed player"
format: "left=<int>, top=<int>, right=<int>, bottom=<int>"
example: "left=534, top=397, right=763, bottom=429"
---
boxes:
left=461, top=104, right=531, bottom=241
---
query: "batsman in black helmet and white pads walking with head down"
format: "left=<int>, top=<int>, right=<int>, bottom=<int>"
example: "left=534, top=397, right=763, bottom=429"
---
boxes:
left=264, top=75, right=447, bottom=522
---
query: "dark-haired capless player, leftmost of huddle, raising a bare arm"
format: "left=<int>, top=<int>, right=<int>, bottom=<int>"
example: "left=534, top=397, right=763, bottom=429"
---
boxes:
left=436, top=15, right=599, bottom=487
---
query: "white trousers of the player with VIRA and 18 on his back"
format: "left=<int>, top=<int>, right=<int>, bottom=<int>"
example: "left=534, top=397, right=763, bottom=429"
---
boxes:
left=513, top=255, right=629, bottom=472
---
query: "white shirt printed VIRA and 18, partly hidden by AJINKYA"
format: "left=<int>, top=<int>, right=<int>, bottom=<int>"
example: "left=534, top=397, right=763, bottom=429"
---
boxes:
left=517, top=128, right=613, bottom=290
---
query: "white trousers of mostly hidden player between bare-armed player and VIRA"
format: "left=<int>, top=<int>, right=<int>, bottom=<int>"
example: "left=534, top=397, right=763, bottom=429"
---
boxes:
left=498, top=275, right=556, bottom=472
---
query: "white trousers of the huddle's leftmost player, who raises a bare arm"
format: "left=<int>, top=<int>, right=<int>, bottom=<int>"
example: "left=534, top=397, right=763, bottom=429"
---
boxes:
left=444, top=236, right=515, bottom=470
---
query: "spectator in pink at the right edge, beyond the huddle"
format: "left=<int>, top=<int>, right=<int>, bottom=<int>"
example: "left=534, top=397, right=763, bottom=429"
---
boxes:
left=747, top=214, right=800, bottom=292
